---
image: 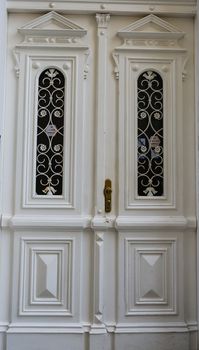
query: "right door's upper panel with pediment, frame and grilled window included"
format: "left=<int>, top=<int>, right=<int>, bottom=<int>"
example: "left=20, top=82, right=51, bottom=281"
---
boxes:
left=113, top=14, right=186, bottom=213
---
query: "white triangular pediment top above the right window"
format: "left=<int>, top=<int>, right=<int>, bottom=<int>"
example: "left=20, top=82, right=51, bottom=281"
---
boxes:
left=118, top=14, right=184, bottom=39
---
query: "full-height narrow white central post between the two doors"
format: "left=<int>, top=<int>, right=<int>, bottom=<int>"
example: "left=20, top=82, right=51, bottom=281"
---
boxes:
left=91, top=13, right=110, bottom=334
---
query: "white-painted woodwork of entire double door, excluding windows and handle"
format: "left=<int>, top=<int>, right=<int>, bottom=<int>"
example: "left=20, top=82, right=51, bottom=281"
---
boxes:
left=0, top=7, right=197, bottom=350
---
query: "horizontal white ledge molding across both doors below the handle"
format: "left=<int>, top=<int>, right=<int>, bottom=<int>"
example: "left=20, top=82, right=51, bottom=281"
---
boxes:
left=1, top=215, right=196, bottom=232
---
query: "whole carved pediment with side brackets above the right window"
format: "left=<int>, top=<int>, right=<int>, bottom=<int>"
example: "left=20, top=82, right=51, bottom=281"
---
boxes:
left=113, top=14, right=187, bottom=80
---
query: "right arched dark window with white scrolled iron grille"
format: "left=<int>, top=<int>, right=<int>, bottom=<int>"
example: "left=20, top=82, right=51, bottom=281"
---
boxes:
left=137, top=70, right=164, bottom=197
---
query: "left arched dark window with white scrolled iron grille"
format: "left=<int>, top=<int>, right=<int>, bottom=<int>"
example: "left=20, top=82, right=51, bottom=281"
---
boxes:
left=36, top=68, right=65, bottom=196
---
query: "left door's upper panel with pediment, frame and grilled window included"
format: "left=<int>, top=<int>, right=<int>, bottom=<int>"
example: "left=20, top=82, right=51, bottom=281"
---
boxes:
left=15, top=11, right=90, bottom=208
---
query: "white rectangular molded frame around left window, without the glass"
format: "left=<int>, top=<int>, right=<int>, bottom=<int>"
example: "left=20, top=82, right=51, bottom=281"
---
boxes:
left=22, top=54, right=76, bottom=209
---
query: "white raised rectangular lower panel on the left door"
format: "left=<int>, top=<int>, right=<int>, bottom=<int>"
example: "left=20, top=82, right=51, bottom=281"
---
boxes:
left=19, top=238, right=74, bottom=316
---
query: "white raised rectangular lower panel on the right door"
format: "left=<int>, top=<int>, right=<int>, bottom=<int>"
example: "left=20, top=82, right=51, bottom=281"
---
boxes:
left=125, top=238, right=176, bottom=315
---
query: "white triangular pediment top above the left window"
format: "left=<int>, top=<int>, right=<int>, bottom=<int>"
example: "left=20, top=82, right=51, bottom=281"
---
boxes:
left=19, top=11, right=86, bottom=37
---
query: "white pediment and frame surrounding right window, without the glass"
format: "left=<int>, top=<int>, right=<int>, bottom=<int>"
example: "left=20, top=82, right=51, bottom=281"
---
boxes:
left=115, top=15, right=186, bottom=211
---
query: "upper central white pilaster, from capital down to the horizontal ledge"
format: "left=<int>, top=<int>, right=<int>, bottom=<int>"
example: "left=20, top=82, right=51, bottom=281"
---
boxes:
left=94, top=13, right=110, bottom=217
